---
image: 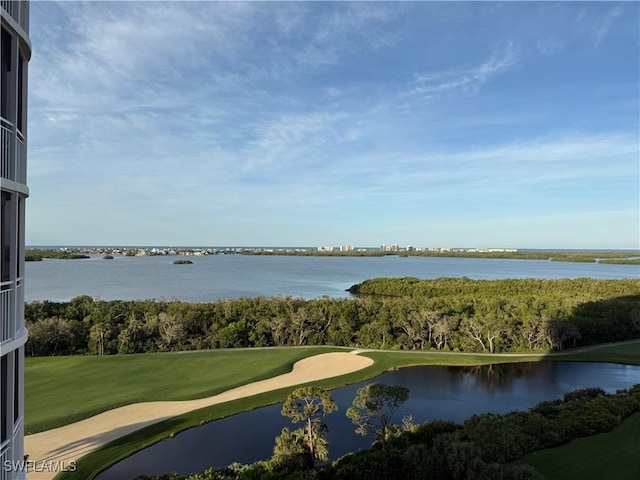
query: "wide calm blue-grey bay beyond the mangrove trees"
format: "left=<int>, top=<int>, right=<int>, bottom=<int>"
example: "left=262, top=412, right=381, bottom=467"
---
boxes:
left=25, top=255, right=640, bottom=302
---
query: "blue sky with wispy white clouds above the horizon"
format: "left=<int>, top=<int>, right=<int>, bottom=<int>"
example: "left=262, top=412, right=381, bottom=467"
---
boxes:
left=26, top=1, right=640, bottom=248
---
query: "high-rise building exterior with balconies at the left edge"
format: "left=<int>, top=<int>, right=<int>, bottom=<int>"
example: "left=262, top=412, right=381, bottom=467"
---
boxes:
left=0, top=0, right=31, bottom=480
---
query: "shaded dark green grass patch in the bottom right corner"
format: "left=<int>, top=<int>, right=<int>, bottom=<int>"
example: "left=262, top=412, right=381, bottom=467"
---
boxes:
left=522, top=413, right=640, bottom=480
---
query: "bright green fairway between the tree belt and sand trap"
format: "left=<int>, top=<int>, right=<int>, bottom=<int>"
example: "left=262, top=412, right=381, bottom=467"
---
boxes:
left=25, top=347, right=340, bottom=433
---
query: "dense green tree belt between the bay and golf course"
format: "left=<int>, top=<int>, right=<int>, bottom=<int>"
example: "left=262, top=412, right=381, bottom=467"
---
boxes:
left=25, top=278, right=640, bottom=355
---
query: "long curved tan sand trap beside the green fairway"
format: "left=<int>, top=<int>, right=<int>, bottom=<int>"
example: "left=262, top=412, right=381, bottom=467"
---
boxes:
left=24, top=352, right=373, bottom=480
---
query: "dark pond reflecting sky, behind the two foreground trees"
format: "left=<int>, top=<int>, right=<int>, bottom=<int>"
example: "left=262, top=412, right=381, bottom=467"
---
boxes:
left=96, top=362, right=640, bottom=480
